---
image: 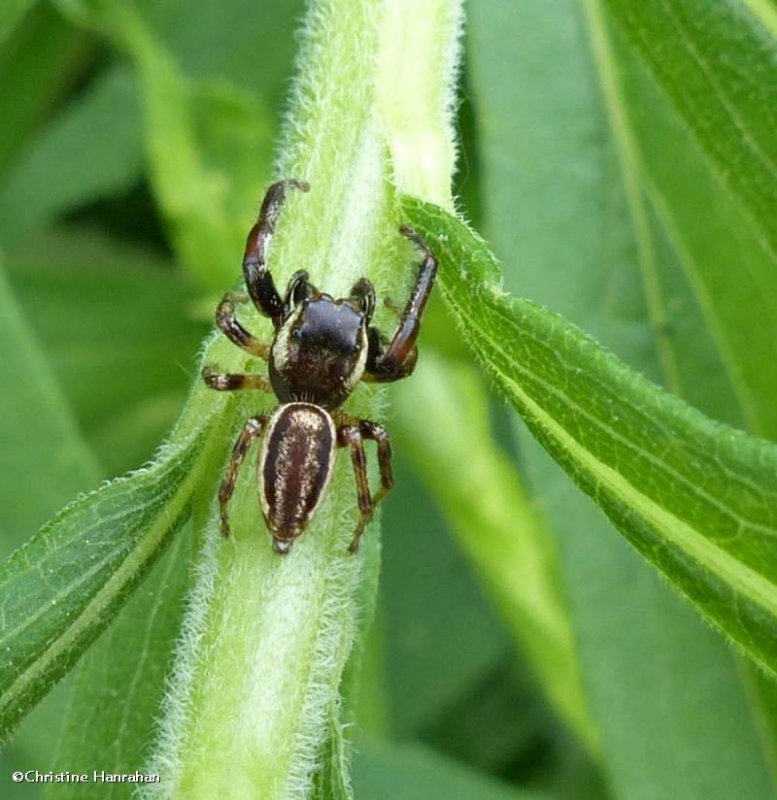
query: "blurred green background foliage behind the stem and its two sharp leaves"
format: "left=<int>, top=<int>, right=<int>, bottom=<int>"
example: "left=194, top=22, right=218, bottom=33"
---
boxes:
left=0, top=0, right=777, bottom=800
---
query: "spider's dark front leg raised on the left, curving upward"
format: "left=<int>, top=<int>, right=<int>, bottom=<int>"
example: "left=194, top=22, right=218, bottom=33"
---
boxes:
left=243, top=179, right=310, bottom=329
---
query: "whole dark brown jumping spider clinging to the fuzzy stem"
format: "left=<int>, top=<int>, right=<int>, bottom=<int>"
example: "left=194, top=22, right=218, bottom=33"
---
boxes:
left=202, top=180, right=437, bottom=554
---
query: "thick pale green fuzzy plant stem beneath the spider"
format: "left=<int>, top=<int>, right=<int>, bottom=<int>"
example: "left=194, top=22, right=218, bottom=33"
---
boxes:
left=141, top=0, right=459, bottom=800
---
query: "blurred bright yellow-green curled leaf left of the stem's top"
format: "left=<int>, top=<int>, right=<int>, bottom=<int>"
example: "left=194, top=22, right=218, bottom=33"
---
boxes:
left=115, top=6, right=272, bottom=291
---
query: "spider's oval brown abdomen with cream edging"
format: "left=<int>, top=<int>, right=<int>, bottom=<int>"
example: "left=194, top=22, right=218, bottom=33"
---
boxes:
left=258, top=403, right=337, bottom=553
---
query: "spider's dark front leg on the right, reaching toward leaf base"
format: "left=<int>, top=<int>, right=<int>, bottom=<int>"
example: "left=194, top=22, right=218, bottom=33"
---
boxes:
left=364, top=225, right=437, bottom=383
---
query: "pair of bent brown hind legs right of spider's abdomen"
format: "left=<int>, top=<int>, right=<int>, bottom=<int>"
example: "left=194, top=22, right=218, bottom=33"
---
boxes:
left=337, top=419, right=394, bottom=553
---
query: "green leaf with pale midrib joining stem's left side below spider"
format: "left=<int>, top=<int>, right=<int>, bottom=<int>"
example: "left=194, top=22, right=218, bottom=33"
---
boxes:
left=0, top=412, right=227, bottom=737
